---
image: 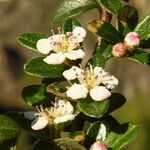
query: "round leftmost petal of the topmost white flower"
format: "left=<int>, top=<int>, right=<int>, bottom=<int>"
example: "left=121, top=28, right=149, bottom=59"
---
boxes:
left=36, top=39, right=51, bottom=54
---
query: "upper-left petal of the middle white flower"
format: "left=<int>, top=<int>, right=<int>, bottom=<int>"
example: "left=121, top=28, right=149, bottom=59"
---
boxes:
left=63, top=66, right=82, bottom=80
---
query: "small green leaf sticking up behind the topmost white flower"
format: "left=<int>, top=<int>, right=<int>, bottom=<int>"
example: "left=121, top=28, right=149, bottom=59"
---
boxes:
left=63, top=19, right=81, bottom=33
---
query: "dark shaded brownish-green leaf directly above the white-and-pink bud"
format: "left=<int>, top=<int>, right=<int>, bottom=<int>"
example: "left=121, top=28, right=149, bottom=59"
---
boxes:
left=118, top=5, right=139, bottom=35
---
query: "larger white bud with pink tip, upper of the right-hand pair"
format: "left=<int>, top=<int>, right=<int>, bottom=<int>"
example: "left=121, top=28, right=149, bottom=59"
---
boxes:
left=124, top=32, right=140, bottom=52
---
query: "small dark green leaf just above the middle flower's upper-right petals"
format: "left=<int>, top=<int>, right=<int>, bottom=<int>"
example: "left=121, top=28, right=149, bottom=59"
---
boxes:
left=91, top=53, right=106, bottom=68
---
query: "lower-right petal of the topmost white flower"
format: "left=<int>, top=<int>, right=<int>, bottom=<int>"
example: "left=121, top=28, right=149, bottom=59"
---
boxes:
left=66, top=49, right=85, bottom=60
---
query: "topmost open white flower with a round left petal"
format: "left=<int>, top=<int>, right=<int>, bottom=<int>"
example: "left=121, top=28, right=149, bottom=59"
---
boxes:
left=36, top=27, right=86, bottom=64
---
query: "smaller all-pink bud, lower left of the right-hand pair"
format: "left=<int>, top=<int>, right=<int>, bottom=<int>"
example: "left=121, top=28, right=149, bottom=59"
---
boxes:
left=112, top=43, right=126, bottom=57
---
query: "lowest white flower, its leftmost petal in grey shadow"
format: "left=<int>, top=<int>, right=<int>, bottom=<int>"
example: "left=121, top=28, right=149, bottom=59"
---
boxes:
left=24, top=100, right=75, bottom=130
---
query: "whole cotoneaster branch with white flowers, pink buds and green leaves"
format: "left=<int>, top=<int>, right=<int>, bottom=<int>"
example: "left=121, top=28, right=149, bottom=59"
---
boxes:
left=0, top=0, right=150, bottom=150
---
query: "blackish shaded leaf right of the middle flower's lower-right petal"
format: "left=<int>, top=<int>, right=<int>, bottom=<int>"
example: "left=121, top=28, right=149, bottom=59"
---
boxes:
left=108, top=93, right=126, bottom=113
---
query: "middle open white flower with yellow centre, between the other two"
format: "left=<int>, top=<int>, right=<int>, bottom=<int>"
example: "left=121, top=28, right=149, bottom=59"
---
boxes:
left=63, top=66, right=118, bottom=101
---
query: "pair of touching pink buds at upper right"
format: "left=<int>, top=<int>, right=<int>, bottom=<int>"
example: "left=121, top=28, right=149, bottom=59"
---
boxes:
left=112, top=32, right=140, bottom=57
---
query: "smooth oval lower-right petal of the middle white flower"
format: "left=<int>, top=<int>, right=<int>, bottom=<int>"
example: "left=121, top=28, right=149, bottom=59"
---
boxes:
left=90, top=86, right=111, bottom=101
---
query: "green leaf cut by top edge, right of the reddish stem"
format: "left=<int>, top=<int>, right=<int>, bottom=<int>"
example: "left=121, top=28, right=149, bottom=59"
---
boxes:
left=97, top=0, right=122, bottom=14
